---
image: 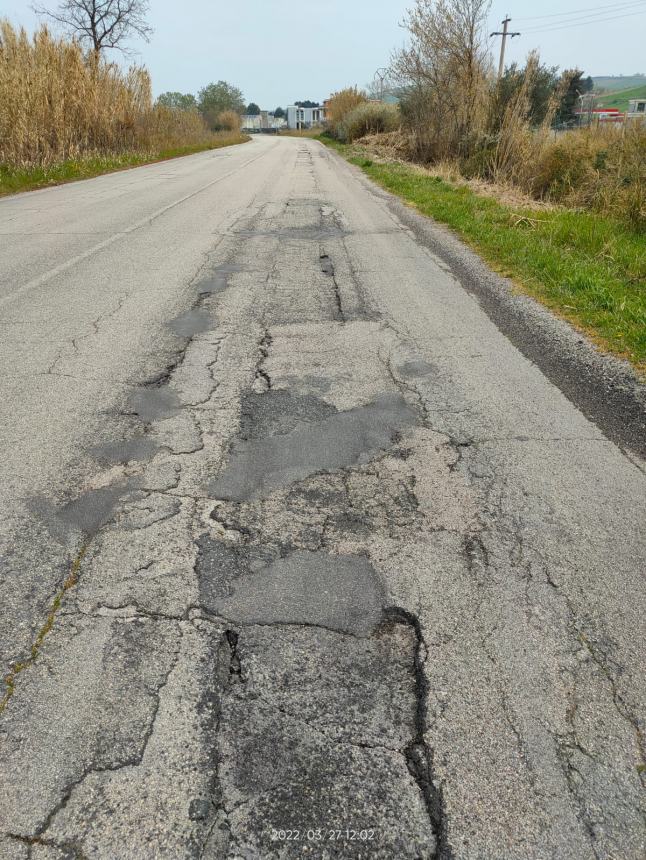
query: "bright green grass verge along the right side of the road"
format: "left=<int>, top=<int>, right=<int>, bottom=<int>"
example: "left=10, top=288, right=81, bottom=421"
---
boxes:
left=320, top=136, right=646, bottom=372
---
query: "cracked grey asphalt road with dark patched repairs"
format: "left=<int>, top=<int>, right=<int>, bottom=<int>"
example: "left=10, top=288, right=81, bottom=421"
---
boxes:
left=0, top=138, right=646, bottom=860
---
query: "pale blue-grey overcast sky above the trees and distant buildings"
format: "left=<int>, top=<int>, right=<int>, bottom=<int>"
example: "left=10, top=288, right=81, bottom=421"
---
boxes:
left=5, top=0, right=646, bottom=109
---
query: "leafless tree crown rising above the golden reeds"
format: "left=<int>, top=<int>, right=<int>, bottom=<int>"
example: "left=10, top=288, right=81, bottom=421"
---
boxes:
left=32, top=0, right=153, bottom=54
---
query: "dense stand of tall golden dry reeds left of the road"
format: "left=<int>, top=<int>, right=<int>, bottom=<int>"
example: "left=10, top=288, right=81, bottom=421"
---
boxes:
left=0, top=20, right=218, bottom=167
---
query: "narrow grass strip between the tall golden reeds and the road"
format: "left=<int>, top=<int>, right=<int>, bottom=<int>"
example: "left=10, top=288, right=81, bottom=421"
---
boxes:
left=0, top=134, right=251, bottom=196
